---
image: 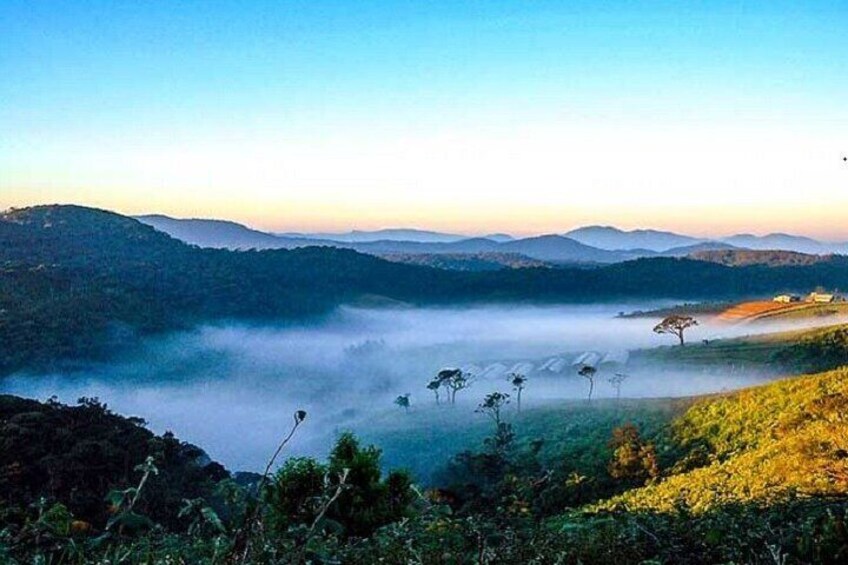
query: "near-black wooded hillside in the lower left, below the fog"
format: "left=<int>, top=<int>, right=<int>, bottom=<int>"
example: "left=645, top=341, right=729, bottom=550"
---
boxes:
left=0, top=395, right=229, bottom=528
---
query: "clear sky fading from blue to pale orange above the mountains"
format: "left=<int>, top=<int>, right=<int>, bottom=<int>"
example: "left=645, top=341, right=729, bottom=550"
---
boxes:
left=0, top=0, right=848, bottom=239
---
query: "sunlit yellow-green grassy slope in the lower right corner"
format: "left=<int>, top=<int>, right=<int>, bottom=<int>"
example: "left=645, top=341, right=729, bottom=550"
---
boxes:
left=601, top=369, right=848, bottom=512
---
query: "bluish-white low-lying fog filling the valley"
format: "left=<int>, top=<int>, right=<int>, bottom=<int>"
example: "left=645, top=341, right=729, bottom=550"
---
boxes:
left=0, top=303, right=836, bottom=470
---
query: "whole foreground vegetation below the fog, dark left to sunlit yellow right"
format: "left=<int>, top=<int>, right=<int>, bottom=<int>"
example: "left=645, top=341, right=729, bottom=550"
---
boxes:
left=0, top=369, right=848, bottom=564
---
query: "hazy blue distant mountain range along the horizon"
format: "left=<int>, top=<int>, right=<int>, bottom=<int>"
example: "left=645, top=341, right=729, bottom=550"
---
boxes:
left=137, top=215, right=848, bottom=267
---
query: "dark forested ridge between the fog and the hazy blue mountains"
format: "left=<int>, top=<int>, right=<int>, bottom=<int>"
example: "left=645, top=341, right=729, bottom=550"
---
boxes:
left=0, top=206, right=848, bottom=374
